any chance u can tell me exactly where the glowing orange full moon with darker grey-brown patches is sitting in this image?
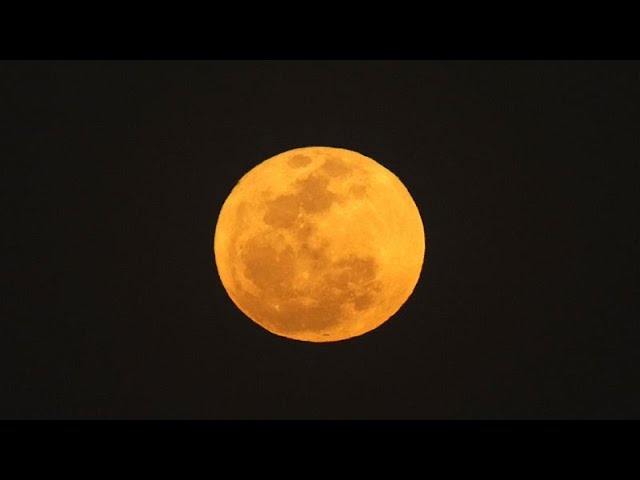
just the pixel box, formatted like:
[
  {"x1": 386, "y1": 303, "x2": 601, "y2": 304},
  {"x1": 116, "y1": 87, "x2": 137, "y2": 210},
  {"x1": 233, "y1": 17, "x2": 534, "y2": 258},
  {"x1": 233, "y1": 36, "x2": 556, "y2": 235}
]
[{"x1": 214, "y1": 147, "x2": 425, "y2": 342}]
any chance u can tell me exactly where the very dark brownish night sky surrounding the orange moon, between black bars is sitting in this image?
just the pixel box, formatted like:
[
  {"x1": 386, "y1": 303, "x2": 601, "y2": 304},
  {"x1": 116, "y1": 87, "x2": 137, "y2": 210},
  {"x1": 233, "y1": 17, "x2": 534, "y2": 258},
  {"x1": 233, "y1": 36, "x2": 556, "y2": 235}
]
[{"x1": 0, "y1": 60, "x2": 640, "y2": 419}]
